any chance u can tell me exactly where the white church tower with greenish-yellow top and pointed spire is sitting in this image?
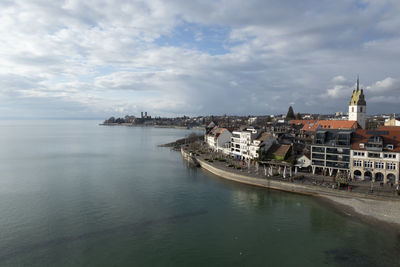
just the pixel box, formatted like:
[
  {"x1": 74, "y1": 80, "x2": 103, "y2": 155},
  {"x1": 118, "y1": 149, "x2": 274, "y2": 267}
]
[{"x1": 349, "y1": 77, "x2": 367, "y2": 129}]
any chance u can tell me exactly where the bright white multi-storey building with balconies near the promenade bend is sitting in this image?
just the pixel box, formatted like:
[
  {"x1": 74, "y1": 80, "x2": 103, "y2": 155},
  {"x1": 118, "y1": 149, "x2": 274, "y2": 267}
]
[{"x1": 231, "y1": 128, "x2": 259, "y2": 159}]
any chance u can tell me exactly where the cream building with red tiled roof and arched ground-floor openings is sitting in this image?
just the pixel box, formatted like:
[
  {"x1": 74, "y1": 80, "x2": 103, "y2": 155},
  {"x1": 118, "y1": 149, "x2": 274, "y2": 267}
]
[{"x1": 350, "y1": 127, "x2": 400, "y2": 184}]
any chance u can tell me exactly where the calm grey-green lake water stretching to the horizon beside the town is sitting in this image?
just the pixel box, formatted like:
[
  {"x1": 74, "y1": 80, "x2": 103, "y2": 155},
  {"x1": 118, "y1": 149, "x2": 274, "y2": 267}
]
[{"x1": 0, "y1": 121, "x2": 400, "y2": 266}]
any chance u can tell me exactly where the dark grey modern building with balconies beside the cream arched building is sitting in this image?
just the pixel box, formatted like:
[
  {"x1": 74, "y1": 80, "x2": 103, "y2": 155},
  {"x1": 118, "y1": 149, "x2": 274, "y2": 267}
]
[{"x1": 311, "y1": 130, "x2": 353, "y2": 176}]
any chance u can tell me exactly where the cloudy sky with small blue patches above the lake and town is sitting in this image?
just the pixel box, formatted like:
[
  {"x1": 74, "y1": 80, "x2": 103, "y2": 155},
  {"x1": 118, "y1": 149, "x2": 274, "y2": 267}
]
[{"x1": 0, "y1": 0, "x2": 400, "y2": 119}]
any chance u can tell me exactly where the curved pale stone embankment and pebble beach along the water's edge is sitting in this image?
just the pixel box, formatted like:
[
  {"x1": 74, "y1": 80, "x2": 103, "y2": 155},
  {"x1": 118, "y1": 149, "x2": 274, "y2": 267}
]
[{"x1": 181, "y1": 149, "x2": 400, "y2": 232}]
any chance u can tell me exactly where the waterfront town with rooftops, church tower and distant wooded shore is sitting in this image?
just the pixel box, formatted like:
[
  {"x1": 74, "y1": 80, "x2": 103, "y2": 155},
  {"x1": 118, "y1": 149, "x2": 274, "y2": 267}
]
[{"x1": 104, "y1": 79, "x2": 400, "y2": 196}]
